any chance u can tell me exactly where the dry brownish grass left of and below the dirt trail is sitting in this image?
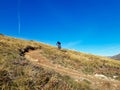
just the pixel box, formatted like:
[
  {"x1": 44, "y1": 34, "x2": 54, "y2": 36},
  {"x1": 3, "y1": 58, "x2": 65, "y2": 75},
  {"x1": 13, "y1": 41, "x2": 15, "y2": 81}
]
[{"x1": 0, "y1": 35, "x2": 94, "y2": 90}]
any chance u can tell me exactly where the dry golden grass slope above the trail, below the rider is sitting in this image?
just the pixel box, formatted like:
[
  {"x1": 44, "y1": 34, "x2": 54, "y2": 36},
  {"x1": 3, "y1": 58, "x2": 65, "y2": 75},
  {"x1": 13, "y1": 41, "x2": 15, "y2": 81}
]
[{"x1": 40, "y1": 43, "x2": 120, "y2": 76}]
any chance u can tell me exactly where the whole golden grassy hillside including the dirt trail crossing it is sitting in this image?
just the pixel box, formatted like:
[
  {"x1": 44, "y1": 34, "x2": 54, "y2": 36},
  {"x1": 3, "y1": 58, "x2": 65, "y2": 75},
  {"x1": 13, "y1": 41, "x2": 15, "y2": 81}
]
[{"x1": 0, "y1": 35, "x2": 120, "y2": 90}]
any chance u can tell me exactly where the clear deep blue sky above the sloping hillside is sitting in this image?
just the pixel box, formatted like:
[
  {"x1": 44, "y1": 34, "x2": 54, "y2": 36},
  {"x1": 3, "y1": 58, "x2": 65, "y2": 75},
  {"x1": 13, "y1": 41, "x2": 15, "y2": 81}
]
[{"x1": 0, "y1": 0, "x2": 120, "y2": 56}]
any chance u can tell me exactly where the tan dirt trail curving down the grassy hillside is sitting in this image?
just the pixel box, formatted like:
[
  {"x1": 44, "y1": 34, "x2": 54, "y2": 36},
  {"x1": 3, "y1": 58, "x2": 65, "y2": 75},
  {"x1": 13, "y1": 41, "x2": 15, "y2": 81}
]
[{"x1": 25, "y1": 50, "x2": 120, "y2": 86}]
